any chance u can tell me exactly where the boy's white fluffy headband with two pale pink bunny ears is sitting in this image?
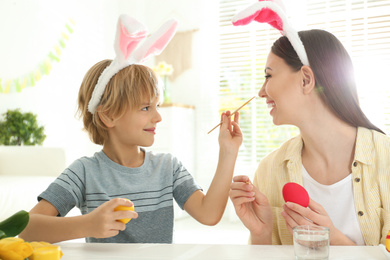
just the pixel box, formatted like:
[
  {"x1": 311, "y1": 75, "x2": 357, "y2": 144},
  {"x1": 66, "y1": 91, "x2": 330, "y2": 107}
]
[{"x1": 88, "y1": 14, "x2": 177, "y2": 114}]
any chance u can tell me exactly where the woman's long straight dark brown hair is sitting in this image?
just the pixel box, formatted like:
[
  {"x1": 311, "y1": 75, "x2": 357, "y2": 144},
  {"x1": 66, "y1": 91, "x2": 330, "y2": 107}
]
[{"x1": 271, "y1": 30, "x2": 385, "y2": 134}]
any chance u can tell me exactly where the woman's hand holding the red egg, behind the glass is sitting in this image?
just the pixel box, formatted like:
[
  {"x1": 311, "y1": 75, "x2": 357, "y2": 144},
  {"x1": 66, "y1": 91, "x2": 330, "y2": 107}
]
[{"x1": 282, "y1": 199, "x2": 355, "y2": 245}]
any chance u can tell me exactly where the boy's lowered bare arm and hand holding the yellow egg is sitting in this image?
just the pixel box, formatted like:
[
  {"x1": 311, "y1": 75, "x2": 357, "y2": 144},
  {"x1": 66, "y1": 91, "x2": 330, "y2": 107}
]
[{"x1": 19, "y1": 198, "x2": 138, "y2": 243}]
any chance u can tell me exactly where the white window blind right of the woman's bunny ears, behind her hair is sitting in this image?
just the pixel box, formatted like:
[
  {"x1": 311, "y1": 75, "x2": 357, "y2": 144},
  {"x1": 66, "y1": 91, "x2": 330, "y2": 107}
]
[{"x1": 306, "y1": 0, "x2": 390, "y2": 134}]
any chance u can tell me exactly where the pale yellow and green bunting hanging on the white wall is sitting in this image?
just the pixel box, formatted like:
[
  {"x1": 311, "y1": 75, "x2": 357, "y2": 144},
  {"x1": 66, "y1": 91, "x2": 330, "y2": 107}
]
[{"x1": 0, "y1": 19, "x2": 75, "y2": 94}]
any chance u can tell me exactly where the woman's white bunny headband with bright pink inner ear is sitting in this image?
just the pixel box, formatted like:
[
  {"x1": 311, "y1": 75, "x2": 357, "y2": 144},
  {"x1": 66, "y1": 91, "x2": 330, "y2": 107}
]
[{"x1": 232, "y1": 0, "x2": 309, "y2": 66}]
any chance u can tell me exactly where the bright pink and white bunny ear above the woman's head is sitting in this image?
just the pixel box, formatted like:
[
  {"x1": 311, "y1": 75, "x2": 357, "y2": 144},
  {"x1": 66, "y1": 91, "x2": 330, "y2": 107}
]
[{"x1": 232, "y1": 1, "x2": 283, "y2": 32}]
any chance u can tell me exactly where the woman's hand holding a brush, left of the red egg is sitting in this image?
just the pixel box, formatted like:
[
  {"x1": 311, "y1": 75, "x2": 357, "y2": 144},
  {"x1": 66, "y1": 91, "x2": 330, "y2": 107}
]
[{"x1": 229, "y1": 176, "x2": 273, "y2": 244}]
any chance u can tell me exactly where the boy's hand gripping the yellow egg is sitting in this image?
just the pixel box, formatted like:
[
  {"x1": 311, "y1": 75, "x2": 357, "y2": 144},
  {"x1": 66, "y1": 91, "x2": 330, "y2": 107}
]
[{"x1": 86, "y1": 198, "x2": 138, "y2": 238}]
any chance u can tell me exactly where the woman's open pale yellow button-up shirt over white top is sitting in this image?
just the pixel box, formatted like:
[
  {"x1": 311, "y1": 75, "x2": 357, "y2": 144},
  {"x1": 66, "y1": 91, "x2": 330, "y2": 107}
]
[{"x1": 253, "y1": 127, "x2": 390, "y2": 245}]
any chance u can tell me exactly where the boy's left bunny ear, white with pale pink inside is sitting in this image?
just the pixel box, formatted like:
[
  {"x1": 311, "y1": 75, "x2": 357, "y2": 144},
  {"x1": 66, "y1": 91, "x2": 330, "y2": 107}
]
[{"x1": 114, "y1": 14, "x2": 148, "y2": 60}]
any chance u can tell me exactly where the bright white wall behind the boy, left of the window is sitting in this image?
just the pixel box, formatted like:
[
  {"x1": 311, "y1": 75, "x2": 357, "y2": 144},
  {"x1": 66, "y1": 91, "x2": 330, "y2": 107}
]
[{"x1": 0, "y1": 0, "x2": 219, "y2": 189}]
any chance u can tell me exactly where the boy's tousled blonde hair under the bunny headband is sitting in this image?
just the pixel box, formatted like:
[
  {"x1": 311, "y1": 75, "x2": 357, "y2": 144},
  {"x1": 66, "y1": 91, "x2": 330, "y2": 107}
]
[{"x1": 78, "y1": 60, "x2": 162, "y2": 145}]
